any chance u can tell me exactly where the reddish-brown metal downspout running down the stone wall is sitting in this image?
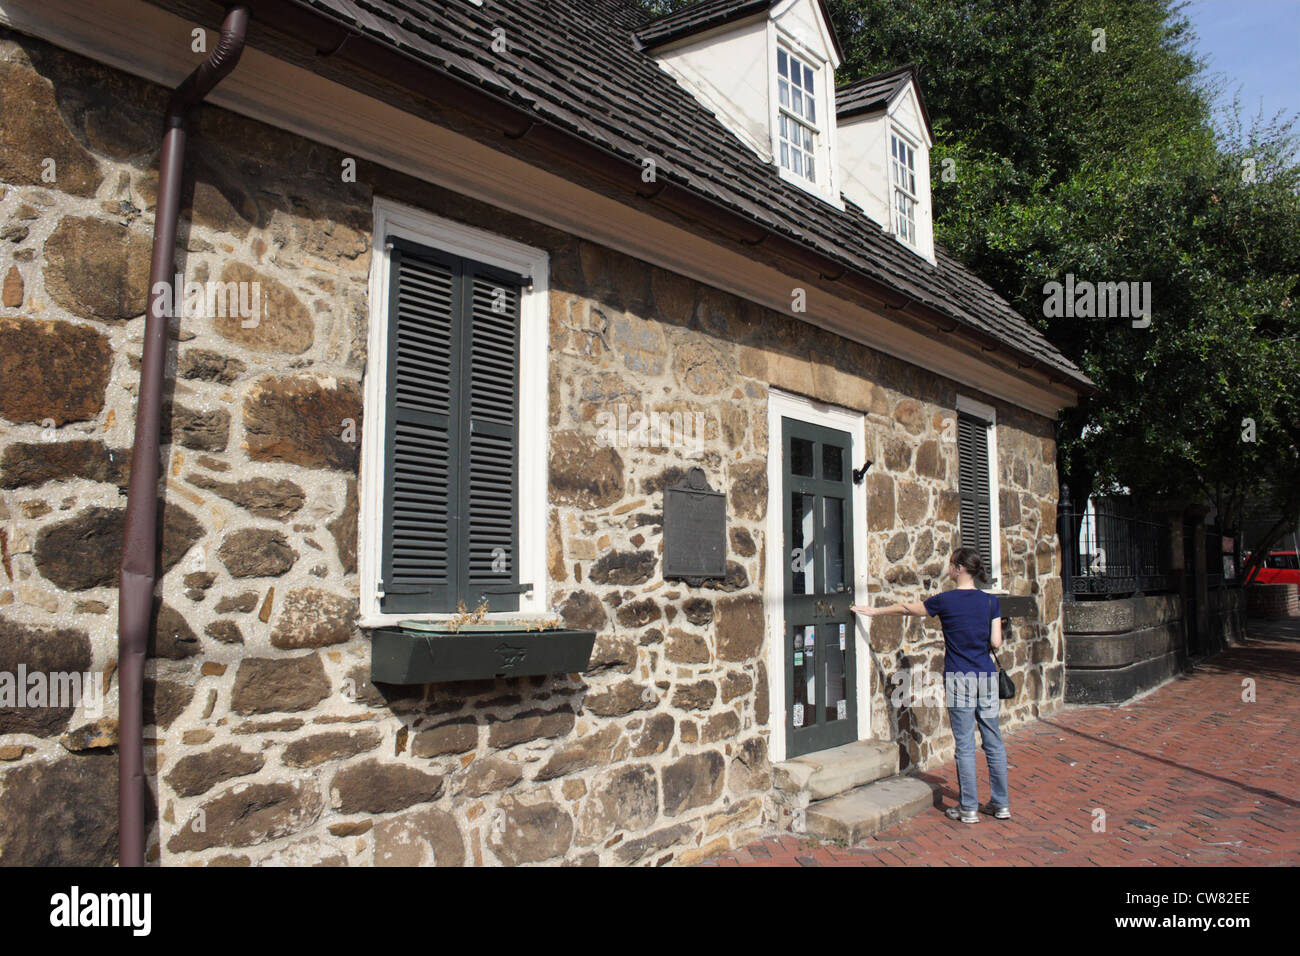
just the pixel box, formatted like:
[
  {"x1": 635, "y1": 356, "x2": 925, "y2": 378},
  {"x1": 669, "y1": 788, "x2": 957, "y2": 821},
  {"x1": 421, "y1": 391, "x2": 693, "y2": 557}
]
[{"x1": 117, "y1": 5, "x2": 248, "y2": 866}]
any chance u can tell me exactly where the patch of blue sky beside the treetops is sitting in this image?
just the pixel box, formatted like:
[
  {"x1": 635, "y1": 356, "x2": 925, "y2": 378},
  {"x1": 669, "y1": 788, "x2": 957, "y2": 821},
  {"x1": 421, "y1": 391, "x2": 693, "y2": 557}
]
[{"x1": 1183, "y1": 0, "x2": 1300, "y2": 126}]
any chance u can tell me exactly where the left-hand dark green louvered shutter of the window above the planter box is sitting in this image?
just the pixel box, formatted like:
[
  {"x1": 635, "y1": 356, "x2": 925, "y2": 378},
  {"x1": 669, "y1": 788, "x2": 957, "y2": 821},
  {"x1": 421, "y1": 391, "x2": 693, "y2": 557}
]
[{"x1": 380, "y1": 241, "x2": 462, "y2": 613}]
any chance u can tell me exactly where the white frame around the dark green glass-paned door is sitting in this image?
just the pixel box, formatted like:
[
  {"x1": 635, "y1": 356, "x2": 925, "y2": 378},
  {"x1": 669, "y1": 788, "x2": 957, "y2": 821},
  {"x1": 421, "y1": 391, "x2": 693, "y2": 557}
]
[{"x1": 763, "y1": 388, "x2": 871, "y2": 762}]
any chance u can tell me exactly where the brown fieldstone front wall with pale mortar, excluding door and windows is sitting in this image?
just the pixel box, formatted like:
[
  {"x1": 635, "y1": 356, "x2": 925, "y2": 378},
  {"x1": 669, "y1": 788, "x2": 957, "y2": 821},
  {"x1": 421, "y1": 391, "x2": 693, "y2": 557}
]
[{"x1": 0, "y1": 33, "x2": 1065, "y2": 865}]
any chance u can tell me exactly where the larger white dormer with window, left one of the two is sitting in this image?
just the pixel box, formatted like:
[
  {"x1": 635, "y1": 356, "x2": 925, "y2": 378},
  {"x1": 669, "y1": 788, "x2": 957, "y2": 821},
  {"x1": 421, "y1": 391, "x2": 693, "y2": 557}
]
[{"x1": 654, "y1": 0, "x2": 844, "y2": 209}]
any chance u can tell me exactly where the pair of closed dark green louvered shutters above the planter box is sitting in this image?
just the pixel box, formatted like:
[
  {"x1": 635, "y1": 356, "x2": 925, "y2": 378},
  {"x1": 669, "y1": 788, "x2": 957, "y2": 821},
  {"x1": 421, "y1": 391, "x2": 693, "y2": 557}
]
[{"x1": 380, "y1": 239, "x2": 529, "y2": 613}]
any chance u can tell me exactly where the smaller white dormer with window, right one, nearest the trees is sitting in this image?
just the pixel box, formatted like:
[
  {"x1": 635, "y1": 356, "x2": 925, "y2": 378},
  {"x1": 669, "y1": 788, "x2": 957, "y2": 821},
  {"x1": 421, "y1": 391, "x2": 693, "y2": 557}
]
[{"x1": 837, "y1": 73, "x2": 935, "y2": 264}]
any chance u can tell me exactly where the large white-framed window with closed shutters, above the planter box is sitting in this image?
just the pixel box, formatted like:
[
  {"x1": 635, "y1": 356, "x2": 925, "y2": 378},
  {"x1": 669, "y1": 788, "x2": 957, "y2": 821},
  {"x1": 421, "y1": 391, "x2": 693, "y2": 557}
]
[{"x1": 358, "y1": 199, "x2": 549, "y2": 627}]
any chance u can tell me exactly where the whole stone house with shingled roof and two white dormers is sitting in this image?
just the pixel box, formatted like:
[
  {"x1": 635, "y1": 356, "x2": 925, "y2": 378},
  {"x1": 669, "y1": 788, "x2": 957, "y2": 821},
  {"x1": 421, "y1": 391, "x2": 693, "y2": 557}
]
[{"x1": 0, "y1": 0, "x2": 1092, "y2": 865}]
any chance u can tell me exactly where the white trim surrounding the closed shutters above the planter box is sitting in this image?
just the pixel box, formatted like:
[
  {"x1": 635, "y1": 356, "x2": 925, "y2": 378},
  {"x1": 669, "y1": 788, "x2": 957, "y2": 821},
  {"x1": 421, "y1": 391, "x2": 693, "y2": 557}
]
[{"x1": 356, "y1": 198, "x2": 550, "y2": 627}]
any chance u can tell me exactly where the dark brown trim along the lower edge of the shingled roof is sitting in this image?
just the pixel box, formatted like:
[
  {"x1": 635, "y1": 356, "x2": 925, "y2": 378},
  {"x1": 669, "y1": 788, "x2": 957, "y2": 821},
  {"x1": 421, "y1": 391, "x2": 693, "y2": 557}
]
[{"x1": 200, "y1": 0, "x2": 1097, "y2": 395}]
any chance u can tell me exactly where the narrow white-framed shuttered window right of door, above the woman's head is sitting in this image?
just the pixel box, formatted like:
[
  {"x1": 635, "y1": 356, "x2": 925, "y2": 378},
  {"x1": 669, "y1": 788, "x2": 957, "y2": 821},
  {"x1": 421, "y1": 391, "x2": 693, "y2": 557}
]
[{"x1": 957, "y1": 395, "x2": 1002, "y2": 591}]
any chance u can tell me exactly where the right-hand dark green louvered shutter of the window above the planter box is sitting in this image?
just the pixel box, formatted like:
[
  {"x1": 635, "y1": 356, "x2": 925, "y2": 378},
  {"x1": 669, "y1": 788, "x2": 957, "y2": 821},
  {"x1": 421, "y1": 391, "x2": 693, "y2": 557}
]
[{"x1": 460, "y1": 263, "x2": 527, "y2": 611}]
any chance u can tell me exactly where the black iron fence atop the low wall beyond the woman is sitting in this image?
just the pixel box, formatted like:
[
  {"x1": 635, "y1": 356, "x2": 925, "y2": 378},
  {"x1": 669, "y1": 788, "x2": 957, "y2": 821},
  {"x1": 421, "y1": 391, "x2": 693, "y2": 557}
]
[{"x1": 1058, "y1": 494, "x2": 1180, "y2": 597}]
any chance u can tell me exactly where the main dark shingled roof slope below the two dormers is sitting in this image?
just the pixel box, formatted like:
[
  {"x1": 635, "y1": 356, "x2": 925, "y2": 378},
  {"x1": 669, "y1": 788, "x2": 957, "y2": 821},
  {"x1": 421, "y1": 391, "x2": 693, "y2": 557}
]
[{"x1": 269, "y1": 0, "x2": 1092, "y2": 392}]
